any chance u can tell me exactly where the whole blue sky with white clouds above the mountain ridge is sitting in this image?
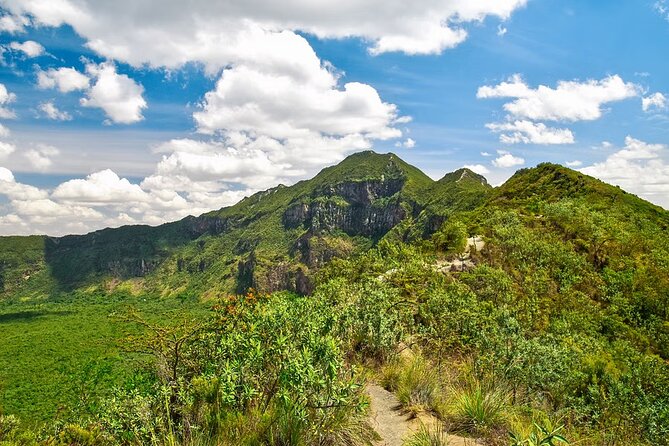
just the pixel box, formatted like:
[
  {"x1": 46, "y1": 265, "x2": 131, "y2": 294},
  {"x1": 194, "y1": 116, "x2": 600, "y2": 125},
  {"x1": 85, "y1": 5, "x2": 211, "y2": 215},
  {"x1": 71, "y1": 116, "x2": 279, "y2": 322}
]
[{"x1": 0, "y1": 0, "x2": 669, "y2": 235}]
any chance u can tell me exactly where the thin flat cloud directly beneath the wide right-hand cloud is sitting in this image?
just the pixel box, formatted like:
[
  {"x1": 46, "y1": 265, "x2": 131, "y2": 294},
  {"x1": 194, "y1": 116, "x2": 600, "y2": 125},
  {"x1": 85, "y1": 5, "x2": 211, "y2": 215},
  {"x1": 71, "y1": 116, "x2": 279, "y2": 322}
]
[{"x1": 486, "y1": 120, "x2": 574, "y2": 144}]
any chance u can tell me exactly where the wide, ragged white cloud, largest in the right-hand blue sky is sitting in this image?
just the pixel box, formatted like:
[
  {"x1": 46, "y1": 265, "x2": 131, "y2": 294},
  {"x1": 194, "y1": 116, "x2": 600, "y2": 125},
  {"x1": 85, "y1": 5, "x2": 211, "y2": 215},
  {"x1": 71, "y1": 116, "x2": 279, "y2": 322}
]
[{"x1": 476, "y1": 75, "x2": 641, "y2": 121}]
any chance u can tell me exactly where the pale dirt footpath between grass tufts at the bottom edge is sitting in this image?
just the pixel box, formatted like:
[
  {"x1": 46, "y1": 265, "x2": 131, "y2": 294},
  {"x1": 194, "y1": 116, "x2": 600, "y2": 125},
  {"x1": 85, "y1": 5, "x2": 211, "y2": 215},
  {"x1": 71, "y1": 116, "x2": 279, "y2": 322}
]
[{"x1": 367, "y1": 383, "x2": 477, "y2": 446}]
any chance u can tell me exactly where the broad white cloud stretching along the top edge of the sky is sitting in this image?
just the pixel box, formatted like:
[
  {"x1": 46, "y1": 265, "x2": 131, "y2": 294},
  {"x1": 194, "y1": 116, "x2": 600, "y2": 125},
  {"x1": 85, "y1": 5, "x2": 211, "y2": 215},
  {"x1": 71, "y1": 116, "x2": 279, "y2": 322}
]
[{"x1": 5, "y1": 0, "x2": 527, "y2": 68}]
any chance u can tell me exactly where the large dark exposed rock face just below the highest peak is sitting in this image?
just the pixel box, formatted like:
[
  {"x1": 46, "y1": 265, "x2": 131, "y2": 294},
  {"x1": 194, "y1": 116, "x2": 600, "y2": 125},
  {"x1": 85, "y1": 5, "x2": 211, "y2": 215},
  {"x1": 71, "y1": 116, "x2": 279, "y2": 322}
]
[{"x1": 283, "y1": 179, "x2": 407, "y2": 237}]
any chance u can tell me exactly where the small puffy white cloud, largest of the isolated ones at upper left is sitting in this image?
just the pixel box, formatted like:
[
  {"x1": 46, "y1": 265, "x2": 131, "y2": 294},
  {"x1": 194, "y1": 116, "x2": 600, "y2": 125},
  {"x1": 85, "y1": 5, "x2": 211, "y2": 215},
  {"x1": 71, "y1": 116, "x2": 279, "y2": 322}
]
[{"x1": 81, "y1": 62, "x2": 147, "y2": 124}]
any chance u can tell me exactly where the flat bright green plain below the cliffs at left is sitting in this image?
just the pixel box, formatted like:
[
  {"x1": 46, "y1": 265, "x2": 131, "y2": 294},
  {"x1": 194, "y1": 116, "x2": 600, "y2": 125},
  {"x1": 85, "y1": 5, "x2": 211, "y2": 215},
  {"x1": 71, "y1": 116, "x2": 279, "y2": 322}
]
[{"x1": 0, "y1": 291, "x2": 207, "y2": 422}]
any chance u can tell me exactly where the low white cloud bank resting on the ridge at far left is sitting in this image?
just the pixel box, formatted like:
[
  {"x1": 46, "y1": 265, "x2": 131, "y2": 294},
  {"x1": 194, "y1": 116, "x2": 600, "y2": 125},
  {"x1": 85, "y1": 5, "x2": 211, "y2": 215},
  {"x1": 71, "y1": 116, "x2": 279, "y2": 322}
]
[{"x1": 0, "y1": 161, "x2": 254, "y2": 235}]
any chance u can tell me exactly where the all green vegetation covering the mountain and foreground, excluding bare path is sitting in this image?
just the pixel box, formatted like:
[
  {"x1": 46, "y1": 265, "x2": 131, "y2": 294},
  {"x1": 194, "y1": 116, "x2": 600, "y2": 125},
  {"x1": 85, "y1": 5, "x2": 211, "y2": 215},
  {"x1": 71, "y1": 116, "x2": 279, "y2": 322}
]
[{"x1": 0, "y1": 152, "x2": 669, "y2": 446}]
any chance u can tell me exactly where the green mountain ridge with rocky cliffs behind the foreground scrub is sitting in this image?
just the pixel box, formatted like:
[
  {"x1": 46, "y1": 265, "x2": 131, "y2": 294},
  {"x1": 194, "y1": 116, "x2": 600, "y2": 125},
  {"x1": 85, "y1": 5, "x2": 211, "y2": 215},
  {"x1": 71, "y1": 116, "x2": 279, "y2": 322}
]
[{"x1": 0, "y1": 151, "x2": 669, "y2": 302}]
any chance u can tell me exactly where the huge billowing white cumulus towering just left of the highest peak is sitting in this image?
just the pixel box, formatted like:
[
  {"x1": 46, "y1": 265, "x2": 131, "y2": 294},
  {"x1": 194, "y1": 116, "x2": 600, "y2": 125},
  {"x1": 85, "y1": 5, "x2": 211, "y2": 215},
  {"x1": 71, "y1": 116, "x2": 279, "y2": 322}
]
[{"x1": 185, "y1": 30, "x2": 408, "y2": 187}]
